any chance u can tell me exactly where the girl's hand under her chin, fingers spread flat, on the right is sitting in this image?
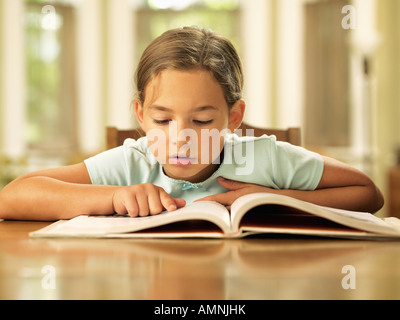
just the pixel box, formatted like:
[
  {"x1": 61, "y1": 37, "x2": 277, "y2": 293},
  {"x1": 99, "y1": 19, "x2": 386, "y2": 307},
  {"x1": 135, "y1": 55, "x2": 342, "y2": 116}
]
[{"x1": 195, "y1": 177, "x2": 276, "y2": 209}]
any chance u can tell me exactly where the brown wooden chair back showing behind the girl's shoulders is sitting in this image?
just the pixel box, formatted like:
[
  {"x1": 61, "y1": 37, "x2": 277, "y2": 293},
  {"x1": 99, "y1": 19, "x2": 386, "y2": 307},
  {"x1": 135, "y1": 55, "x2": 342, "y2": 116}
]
[{"x1": 106, "y1": 123, "x2": 301, "y2": 149}]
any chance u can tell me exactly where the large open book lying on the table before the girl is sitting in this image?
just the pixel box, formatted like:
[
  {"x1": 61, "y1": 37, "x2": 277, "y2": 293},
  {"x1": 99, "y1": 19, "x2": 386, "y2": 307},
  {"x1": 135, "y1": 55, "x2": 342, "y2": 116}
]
[{"x1": 30, "y1": 193, "x2": 400, "y2": 239}]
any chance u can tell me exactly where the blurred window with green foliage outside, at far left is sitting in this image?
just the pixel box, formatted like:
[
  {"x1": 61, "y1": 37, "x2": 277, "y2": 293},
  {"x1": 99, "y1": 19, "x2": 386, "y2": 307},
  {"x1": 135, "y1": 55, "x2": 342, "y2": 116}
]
[{"x1": 25, "y1": 0, "x2": 77, "y2": 154}]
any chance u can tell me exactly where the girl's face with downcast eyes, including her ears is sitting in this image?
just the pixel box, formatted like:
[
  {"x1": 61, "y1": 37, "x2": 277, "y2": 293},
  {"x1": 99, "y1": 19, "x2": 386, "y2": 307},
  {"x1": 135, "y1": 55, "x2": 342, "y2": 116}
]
[{"x1": 135, "y1": 69, "x2": 245, "y2": 182}]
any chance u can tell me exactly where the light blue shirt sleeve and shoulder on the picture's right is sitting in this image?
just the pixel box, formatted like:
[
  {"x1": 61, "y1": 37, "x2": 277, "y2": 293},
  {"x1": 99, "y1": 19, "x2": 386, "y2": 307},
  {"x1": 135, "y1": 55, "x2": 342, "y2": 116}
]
[{"x1": 221, "y1": 135, "x2": 324, "y2": 190}]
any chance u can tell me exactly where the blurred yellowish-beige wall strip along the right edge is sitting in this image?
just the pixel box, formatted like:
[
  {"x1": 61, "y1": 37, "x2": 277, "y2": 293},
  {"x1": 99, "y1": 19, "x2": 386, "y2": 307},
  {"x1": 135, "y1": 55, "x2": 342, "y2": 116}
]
[{"x1": 374, "y1": 0, "x2": 400, "y2": 215}]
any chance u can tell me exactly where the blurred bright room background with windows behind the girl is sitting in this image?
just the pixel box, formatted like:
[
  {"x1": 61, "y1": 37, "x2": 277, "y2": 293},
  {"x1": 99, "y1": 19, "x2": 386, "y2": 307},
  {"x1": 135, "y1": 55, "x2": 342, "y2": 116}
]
[{"x1": 0, "y1": 0, "x2": 400, "y2": 215}]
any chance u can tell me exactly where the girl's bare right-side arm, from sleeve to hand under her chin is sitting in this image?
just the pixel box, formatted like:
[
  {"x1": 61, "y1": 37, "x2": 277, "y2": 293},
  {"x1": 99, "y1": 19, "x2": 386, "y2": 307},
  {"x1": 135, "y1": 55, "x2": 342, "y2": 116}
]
[{"x1": 199, "y1": 157, "x2": 384, "y2": 213}]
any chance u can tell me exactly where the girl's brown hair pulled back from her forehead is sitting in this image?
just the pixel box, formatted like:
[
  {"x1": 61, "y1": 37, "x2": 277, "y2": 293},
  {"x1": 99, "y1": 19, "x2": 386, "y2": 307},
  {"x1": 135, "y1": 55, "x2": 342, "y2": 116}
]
[{"x1": 135, "y1": 27, "x2": 243, "y2": 107}]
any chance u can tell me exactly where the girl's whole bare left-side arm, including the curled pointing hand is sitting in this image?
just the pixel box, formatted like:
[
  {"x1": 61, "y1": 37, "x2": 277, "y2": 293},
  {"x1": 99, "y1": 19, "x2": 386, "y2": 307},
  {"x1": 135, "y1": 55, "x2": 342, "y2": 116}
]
[{"x1": 0, "y1": 163, "x2": 185, "y2": 221}]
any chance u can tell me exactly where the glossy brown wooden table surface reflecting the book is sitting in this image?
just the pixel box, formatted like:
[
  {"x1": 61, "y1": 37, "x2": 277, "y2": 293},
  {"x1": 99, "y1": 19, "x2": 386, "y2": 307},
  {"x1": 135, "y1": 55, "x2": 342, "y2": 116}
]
[{"x1": 0, "y1": 221, "x2": 400, "y2": 300}]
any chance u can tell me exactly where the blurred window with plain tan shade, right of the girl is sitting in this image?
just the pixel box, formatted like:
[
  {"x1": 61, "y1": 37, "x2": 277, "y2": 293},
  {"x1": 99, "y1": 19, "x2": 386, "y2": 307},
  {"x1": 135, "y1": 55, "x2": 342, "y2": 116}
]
[{"x1": 304, "y1": 1, "x2": 351, "y2": 147}]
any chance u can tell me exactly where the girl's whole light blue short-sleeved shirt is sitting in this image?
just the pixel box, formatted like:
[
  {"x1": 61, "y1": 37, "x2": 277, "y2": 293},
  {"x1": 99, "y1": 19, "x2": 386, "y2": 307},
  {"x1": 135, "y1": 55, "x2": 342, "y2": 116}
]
[{"x1": 85, "y1": 134, "x2": 324, "y2": 204}]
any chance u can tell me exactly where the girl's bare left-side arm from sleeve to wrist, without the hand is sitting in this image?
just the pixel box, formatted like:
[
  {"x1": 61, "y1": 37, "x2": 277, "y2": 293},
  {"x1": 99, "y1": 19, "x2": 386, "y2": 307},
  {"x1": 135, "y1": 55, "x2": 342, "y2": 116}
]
[{"x1": 0, "y1": 163, "x2": 114, "y2": 220}]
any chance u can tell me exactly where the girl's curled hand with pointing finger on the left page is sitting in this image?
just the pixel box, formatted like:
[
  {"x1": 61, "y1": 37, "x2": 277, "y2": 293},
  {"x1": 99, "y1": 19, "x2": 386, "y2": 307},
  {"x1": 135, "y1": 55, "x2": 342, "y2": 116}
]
[{"x1": 112, "y1": 183, "x2": 186, "y2": 217}]
